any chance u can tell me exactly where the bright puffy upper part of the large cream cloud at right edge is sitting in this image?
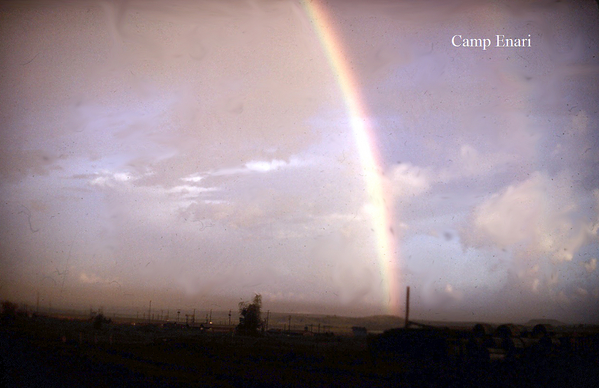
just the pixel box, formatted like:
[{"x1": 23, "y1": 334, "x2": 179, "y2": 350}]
[{"x1": 462, "y1": 173, "x2": 597, "y2": 262}]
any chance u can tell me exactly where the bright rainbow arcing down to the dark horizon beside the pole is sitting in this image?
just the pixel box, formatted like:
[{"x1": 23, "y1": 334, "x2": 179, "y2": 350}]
[{"x1": 302, "y1": 0, "x2": 399, "y2": 314}]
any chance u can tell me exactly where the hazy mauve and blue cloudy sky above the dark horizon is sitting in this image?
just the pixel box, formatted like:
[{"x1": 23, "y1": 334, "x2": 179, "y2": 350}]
[{"x1": 0, "y1": 0, "x2": 599, "y2": 323}]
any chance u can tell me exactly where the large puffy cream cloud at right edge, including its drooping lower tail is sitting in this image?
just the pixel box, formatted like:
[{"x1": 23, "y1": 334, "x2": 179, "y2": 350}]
[{"x1": 460, "y1": 172, "x2": 599, "y2": 303}]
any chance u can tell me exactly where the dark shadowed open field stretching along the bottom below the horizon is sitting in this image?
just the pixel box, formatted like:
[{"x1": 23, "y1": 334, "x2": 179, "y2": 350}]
[{"x1": 1, "y1": 316, "x2": 599, "y2": 387}]
